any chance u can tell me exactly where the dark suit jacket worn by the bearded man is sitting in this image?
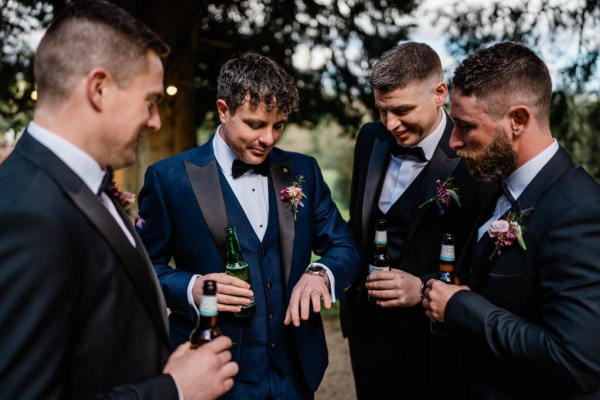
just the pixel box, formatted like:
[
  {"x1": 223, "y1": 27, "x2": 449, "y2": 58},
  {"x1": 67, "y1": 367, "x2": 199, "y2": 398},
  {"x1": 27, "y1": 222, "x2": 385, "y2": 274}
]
[{"x1": 445, "y1": 148, "x2": 600, "y2": 400}]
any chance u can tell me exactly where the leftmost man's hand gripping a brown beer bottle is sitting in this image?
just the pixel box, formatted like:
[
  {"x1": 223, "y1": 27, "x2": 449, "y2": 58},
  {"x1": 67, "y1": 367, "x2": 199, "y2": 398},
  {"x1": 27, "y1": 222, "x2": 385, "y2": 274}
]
[{"x1": 163, "y1": 336, "x2": 239, "y2": 400}]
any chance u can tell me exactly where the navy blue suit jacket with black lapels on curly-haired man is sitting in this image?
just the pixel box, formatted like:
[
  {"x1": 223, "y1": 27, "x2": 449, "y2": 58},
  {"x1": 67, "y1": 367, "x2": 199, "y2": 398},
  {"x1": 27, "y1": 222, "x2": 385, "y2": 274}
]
[{"x1": 139, "y1": 138, "x2": 360, "y2": 390}]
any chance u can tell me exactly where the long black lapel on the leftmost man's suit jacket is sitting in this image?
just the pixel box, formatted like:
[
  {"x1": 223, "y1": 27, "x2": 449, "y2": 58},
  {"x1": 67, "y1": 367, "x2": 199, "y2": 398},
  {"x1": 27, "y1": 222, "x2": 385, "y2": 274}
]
[{"x1": 20, "y1": 134, "x2": 169, "y2": 345}]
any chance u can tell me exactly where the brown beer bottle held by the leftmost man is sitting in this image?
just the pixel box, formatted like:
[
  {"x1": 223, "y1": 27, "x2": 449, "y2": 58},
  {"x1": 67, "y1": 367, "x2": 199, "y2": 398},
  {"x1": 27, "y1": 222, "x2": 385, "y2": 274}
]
[{"x1": 190, "y1": 279, "x2": 221, "y2": 349}]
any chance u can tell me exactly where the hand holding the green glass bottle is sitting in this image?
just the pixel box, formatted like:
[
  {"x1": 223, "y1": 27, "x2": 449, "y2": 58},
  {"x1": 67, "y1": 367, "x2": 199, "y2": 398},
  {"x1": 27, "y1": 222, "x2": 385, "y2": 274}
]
[{"x1": 192, "y1": 272, "x2": 254, "y2": 312}]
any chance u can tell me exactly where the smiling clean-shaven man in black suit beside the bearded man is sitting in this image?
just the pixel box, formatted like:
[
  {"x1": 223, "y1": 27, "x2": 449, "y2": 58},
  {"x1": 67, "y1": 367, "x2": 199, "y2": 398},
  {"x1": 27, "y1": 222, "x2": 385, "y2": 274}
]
[{"x1": 341, "y1": 42, "x2": 486, "y2": 399}]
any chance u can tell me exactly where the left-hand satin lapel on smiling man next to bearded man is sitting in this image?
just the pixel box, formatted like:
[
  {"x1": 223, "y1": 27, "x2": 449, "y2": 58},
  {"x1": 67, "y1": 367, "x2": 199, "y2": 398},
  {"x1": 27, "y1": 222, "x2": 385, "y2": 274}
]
[{"x1": 361, "y1": 138, "x2": 390, "y2": 248}]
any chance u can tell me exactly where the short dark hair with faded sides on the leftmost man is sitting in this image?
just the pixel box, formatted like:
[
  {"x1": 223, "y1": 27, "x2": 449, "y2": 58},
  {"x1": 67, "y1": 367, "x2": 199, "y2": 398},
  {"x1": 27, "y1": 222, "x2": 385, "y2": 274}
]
[{"x1": 34, "y1": 0, "x2": 169, "y2": 104}]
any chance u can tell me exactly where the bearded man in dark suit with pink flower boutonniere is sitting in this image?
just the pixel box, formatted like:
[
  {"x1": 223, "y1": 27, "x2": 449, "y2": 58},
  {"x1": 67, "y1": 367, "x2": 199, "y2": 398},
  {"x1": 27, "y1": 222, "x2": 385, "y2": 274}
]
[{"x1": 423, "y1": 42, "x2": 600, "y2": 400}]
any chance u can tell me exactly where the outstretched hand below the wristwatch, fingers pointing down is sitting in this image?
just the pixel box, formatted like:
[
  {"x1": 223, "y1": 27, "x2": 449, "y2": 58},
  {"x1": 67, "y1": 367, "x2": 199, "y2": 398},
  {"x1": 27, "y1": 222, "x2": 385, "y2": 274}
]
[{"x1": 283, "y1": 274, "x2": 331, "y2": 327}]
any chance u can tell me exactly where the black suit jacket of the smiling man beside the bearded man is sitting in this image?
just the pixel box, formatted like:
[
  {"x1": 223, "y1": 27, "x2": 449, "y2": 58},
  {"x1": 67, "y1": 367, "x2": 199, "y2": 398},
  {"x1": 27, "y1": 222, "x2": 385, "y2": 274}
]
[{"x1": 341, "y1": 117, "x2": 480, "y2": 343}]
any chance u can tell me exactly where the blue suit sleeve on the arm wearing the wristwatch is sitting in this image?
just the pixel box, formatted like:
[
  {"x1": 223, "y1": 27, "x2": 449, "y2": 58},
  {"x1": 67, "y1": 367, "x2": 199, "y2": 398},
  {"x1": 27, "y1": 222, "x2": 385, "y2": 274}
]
[{"x1": 313, "y1": 159, "x2": 361, "y2": 298}]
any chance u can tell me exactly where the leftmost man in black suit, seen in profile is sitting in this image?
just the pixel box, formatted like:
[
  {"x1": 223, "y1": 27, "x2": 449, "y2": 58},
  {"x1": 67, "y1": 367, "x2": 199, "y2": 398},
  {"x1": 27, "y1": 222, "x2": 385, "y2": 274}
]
[{"x1": 0, "y1": 1, "x2": 237, "y2": 400}]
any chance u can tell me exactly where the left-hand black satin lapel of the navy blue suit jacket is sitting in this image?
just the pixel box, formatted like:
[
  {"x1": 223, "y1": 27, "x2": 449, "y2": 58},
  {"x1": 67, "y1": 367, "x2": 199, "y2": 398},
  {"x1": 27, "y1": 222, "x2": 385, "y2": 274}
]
[{"x1": 185, "y1": 158, "x2": 227, "y2": 260}]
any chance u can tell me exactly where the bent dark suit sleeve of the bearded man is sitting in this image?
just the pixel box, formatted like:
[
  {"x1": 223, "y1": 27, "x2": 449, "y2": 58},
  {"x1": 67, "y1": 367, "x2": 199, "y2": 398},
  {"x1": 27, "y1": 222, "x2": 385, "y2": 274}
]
[{"x1": 445, "y1": 202, "x2": 600, "y2": 392}]
